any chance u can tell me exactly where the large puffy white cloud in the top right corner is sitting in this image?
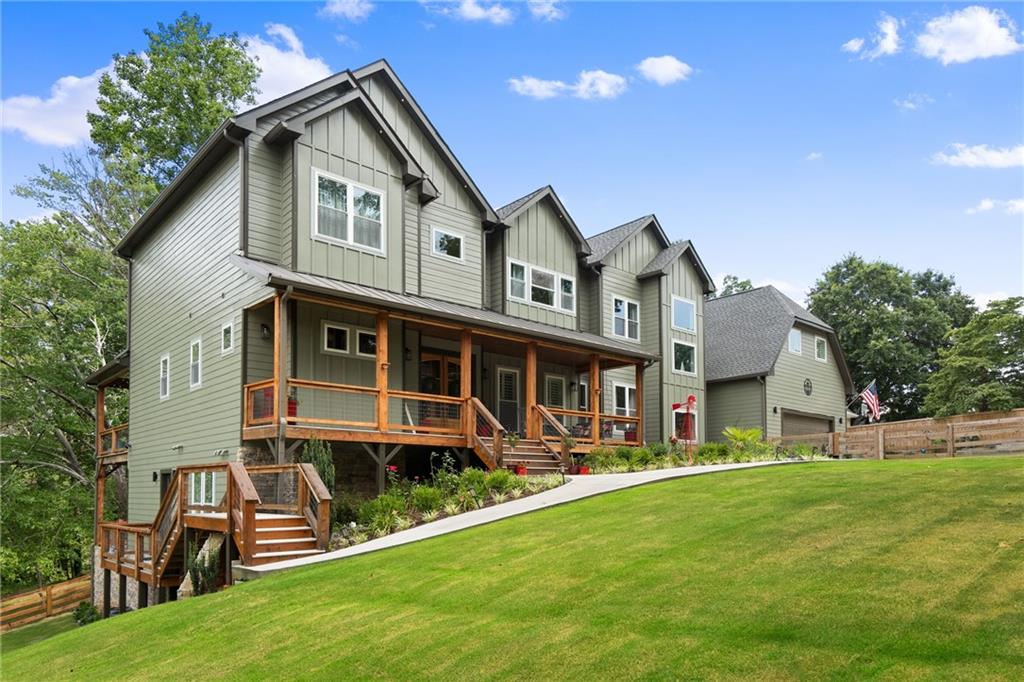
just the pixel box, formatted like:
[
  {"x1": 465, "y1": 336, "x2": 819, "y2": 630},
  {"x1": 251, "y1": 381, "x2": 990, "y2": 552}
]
[{"x1": 916, "y1": 5, "x2": 1024, "y2": 66}]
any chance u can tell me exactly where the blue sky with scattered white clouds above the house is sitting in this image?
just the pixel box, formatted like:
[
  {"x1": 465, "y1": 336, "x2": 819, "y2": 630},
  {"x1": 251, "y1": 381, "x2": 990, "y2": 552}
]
[{"x1": 0, "y1": 0, "x2": 1024, "y2": 300}]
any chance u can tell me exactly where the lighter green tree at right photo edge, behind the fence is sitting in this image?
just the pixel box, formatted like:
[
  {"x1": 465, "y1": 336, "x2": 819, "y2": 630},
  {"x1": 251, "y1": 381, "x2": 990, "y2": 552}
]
[{"x1": 925, "y1": 297, "x2": 1024, "y2": 417}]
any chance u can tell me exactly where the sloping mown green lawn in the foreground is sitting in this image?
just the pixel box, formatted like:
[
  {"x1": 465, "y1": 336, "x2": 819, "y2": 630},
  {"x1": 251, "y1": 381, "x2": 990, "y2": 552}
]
[{"x1": 2, "y1": 458, "x2": 1024, "y2": 680}]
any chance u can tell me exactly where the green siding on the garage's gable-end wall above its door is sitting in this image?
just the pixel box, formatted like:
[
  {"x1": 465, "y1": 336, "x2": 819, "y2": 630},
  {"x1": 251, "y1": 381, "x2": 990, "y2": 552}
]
[{"x1": 765, "y1": 325, "x2": 846, "y2": 437}]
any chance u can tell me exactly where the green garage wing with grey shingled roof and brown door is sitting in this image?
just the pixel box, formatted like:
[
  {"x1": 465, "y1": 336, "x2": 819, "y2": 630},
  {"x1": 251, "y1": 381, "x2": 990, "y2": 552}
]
[{"x1": 705, "y1": 287, "x2": 853, "y2": 440}]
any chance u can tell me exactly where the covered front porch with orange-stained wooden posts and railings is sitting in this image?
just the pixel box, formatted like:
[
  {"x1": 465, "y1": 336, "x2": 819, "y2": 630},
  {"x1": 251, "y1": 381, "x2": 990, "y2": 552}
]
[{"x1": 243, "y1": 288, "x2": 650, "y2": 468}]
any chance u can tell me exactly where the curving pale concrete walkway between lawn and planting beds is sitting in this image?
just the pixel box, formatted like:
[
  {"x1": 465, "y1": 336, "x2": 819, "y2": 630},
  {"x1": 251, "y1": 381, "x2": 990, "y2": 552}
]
[{"x1": 233, "y1": 461, "x2": 799, "y2": 580}]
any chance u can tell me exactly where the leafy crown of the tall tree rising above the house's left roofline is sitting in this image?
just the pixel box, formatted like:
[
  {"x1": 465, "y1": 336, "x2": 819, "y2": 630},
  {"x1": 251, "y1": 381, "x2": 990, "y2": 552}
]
[{"x1": 88, "y1": 12, "x2": 260, "y2": 185}]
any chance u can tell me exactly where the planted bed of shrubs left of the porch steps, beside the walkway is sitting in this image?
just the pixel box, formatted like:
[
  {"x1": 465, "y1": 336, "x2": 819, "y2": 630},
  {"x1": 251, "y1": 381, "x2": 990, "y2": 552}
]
[{"x1": 329, "y1": 453, "x2": 563, "y2": 550}]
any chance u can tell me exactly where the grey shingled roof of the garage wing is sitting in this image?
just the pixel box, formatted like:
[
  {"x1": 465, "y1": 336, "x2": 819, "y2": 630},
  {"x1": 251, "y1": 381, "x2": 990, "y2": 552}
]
[{"x1": 705, "y1": 286, "x2": 853, "y2": 392}]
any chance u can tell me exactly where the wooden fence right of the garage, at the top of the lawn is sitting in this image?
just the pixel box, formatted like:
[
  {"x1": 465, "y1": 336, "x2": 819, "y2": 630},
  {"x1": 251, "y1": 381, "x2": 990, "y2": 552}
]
[{"x1": 771, "y1": 410, "x2": 1024, "y2": 459}]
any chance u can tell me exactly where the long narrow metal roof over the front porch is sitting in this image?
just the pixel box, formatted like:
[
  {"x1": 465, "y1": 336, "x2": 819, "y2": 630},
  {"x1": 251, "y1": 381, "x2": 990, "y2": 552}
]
[{"x1": 230, "y1": 255, "x2": 657, "y2": 360}]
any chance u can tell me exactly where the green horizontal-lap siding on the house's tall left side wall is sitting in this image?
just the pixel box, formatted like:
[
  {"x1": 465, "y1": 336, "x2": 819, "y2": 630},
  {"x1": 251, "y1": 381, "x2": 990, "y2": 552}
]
[{"x1": 128, "y1": 154, "x2": 267, "y2": 522}]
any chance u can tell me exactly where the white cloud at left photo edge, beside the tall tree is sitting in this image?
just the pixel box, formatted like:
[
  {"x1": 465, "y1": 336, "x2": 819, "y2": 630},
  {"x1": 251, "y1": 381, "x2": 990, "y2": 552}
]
[{"x1": 0, "y1": 65, "x2": 112, "y2": 146}]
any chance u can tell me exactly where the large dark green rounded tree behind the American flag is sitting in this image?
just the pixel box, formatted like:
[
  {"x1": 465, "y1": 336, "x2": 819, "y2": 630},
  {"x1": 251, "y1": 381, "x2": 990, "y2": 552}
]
[{"x1": 809, "y1": 254, "x2": 976, "y2": 420}]
